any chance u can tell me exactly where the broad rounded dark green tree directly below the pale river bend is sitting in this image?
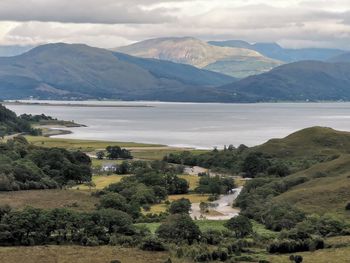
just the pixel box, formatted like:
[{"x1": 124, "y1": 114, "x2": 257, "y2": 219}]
[{"x1": 156, "y1": 214, "x2": 201, "y2": 245}]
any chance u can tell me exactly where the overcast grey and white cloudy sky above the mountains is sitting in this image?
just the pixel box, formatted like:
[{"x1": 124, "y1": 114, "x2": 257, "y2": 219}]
[{"x1": 0, "y1": 0, "x2": 350, "y2": 50}]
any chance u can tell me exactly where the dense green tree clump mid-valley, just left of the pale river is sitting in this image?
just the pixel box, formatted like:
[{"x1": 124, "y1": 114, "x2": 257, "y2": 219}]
[{"x1": 98, "y1": 161, "x2": 189, "y2": 218}]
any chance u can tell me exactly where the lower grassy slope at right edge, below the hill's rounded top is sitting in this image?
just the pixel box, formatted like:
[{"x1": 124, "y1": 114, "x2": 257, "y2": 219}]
[{"x1": 275, "y1": 154, "x2": 350, "y2": 219}]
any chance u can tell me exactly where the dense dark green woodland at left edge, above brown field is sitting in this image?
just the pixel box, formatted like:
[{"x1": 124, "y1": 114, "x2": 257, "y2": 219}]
[{"x1": 0, "y1": 136, "x2": 91, "y2": 191}]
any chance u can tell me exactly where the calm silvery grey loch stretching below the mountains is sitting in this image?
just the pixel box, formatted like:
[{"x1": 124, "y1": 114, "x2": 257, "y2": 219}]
[{"x1": 8, "y1": 102, "x2": 350, "y2": 148}]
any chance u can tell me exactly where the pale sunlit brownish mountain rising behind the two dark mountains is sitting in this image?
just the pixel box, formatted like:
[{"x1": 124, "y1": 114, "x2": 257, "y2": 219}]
[{"x1": 114, "y1": 37, "x2": 282, "y2": 78}]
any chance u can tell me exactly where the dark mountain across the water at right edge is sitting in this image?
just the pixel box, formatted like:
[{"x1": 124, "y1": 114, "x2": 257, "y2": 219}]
[{"x1": 219, "y1": 61, "x2": 350, "y2": 102}]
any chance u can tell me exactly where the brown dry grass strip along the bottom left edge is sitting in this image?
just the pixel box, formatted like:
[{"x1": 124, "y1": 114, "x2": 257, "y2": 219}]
[{"x1": 0, "y1": 246, "x2": 169, "y2": 263}]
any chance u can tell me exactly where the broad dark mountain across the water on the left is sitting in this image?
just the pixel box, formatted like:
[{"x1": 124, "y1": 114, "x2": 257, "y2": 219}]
[{"x1": 0, "y1": 43, "x2": 235, "y2": 101}]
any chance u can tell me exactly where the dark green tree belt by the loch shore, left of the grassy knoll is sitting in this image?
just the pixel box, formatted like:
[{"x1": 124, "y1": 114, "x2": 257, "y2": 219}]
[{"x1": 164, "y1": 150, "x2": 290, "y2": 178}]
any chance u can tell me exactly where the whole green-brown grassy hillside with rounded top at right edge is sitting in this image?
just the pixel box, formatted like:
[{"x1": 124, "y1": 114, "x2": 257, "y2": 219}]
[{"x1": 253, "y1": 127, "x2": 350, "y2": 218}]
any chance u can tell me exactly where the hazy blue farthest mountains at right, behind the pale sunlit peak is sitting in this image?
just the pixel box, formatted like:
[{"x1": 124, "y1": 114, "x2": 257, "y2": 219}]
[{"x1": 208, "y1": 40, "x2": 345, "y2": 62}]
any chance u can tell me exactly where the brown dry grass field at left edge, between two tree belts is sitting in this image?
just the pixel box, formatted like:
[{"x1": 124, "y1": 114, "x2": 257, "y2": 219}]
[{"x1": 0, "y1": 190, "x2": 98, "y2": 212}]
